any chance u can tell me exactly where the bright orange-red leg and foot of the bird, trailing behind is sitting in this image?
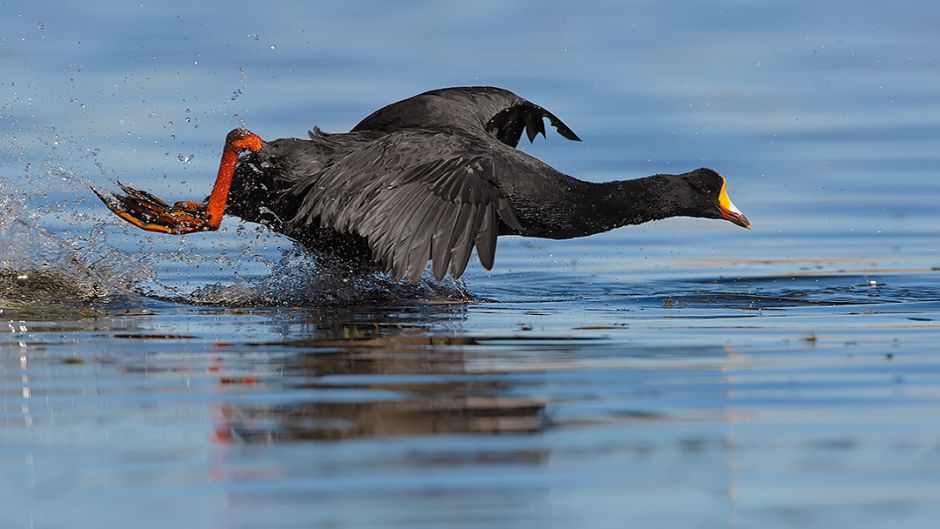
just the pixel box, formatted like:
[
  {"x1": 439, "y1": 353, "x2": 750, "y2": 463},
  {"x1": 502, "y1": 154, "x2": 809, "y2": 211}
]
[{"x1": 92, "y1": 129, "x2": 264, "y2": 235}]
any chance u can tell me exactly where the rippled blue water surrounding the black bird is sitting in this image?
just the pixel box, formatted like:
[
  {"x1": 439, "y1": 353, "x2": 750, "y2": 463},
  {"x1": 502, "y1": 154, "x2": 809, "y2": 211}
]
[{"x1": 0, "y1": 1, "x2": 940, "y2": 528}]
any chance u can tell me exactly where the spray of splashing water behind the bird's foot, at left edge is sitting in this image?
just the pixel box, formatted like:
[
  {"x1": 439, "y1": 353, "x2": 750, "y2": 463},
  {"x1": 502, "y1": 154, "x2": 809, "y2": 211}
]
[{"x1": 0, "y1": 127, "x2": 152, "y2": 318}]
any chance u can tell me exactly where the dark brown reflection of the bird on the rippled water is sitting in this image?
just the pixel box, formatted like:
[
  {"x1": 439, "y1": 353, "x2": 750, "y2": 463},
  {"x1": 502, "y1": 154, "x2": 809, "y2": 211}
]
[{"x1": 218, "y1": 312, "x2": 547, "y2": 443}]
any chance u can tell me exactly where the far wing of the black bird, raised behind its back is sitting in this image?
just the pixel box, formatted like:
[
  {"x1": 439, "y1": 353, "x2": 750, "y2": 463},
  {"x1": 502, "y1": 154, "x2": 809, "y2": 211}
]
[{"x1": 352, "y1": 86, "x2": 581, "y2": 147}]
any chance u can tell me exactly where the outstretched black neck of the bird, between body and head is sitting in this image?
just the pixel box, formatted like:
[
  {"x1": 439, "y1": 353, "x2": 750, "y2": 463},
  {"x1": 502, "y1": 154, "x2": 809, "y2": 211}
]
[{"x1": 552, "y1": 175, "x2": 689, "y2": 238}]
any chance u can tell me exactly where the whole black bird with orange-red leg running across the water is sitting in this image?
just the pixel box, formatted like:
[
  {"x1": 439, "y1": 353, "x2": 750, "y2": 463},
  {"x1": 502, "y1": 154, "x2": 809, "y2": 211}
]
[{"x1": 95, "y1": 87, "x2": 750, "y2": 280}]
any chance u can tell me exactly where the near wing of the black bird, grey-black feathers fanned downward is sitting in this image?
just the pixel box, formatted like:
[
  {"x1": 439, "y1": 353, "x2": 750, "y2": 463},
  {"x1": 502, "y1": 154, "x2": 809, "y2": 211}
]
[{"x1": 290, "y1": 129, "x2": 520, "y2": 281}]
